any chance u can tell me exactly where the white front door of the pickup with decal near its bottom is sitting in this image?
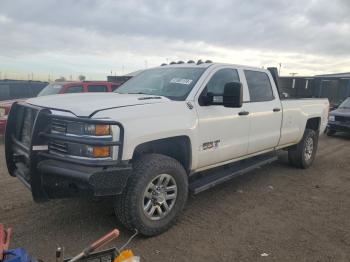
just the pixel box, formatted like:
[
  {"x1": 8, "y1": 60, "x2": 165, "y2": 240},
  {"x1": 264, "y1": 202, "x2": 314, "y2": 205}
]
[{"x1": 197, "y1": 67, "x2": 250, "y2": 168}]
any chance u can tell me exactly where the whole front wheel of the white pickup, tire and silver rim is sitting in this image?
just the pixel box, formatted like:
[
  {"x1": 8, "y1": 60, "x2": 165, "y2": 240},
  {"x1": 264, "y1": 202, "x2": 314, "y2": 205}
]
[{"x1": 115, "y1": 154, "x2": 188, "y2": 236}]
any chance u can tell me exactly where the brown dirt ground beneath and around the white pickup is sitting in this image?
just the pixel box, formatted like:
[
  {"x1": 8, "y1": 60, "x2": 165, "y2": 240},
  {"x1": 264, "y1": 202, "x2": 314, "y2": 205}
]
[{"x1": 0, "y1": 134, "x2": 350, "y2": 262}]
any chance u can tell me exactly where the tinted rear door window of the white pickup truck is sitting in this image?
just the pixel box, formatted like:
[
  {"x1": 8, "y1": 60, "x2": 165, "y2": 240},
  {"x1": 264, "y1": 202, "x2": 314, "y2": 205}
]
[{"x1": 244, "y1": 70, "x2": 274, "y2": 102}]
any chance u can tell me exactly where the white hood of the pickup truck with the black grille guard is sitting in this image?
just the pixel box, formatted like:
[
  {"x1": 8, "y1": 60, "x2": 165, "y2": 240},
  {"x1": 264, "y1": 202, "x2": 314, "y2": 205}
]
[{"x1": 27, "y1": 93, "x2": 170, "y2": 116}]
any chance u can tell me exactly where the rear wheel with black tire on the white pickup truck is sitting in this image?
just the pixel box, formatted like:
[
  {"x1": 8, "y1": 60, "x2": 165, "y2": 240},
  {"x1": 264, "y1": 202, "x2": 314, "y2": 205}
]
[{"x1": 288, "y1": 129, "x2": 318, "y2": 169}]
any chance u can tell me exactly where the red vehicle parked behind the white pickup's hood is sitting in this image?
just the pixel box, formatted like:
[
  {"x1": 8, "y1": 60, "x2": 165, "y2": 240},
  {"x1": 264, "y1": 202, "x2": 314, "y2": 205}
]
[{"x1": 0, "y1": 81, "x2": 121, "y2": 135}]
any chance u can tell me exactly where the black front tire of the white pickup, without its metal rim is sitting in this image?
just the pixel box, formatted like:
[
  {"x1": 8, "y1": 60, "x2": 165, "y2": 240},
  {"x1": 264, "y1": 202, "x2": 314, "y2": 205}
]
[{"x1": 114, "y1": 154, "x2": 188, "y2": 236}]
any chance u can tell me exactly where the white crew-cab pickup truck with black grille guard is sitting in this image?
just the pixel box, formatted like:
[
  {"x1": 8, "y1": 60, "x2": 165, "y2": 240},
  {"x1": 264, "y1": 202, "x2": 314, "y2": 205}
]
[{"x1": 5, "y1": 62, "x2": 329, "y2": 236}]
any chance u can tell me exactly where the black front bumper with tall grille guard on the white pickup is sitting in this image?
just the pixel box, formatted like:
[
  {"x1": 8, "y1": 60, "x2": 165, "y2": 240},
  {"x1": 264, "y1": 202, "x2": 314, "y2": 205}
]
[{"x1": 5, "y1": 101, "x2": 132, "y2": 202}]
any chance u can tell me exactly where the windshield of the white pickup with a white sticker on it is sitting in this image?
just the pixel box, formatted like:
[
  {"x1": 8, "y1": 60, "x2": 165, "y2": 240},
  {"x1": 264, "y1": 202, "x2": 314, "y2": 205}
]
[{"x1": 115, "y1": 67, "x2": 205, "y2": 100}]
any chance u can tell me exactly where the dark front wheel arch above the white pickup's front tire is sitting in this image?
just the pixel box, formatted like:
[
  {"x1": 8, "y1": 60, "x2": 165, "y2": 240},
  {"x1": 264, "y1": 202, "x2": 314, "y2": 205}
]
[{"x1": 132, "y1": 135, "x2": 192, "y2": 173}]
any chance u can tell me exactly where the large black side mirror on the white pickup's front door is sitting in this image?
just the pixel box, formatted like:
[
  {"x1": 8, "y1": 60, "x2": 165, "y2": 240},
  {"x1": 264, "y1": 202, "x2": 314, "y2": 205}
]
[{"x1": 222, "y1": 82, "x2": 243, "y2": 108}]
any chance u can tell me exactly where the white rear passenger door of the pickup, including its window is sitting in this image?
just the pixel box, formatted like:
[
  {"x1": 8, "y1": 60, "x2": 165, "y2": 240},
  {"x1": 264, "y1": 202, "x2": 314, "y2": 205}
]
[{"x1": 243, "y1": 70, "x2": 282, "y2": 154}]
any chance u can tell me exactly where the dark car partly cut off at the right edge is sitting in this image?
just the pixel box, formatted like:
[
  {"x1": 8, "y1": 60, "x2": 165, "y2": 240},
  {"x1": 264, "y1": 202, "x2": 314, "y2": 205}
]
[{"x1": 327, "y1": 97, "x2": 350, "y2": 136}]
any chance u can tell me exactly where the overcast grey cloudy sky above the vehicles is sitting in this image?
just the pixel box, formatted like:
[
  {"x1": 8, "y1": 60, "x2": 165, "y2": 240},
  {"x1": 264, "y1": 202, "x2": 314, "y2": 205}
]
[{"x1": 0, "y1": 0, "x2": 350, "y2": 80}]
